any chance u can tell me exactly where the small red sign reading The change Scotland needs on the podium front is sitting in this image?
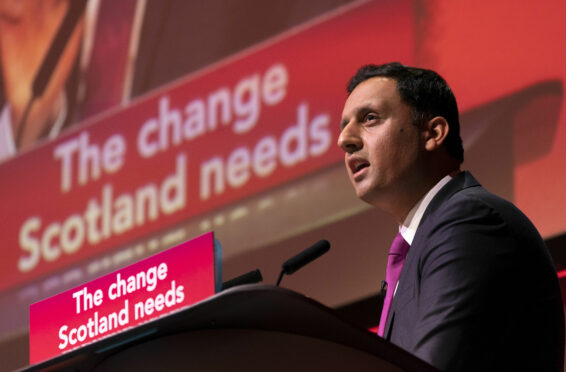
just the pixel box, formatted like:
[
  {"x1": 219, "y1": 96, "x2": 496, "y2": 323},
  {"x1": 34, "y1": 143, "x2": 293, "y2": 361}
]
[{"x1": 29, "y1": 232, "x2": 220, "y2": 364}]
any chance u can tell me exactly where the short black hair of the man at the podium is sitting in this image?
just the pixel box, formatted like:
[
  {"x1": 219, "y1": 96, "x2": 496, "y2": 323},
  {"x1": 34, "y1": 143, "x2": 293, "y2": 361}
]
[{"x1": 347, "y1": 62, "x2": 464, "y2": 163}]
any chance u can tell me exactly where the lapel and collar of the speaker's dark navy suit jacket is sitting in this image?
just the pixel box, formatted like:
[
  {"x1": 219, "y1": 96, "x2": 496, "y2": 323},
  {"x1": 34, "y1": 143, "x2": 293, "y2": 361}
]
[{"x1": 383, "y1": 171, "x2": 480, "y2": 340}]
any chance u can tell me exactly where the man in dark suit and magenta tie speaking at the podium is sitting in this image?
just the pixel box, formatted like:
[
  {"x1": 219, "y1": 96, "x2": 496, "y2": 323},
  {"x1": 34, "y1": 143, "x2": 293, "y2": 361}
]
[{"x1": 338, "y1": 63, "x2": 564, "y2": 371}]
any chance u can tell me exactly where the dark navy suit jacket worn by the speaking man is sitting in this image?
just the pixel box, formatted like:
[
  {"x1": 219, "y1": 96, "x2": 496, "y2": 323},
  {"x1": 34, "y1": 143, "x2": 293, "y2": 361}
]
[{"x1": 384, "y1": 172, "x2": 564, "y2": 371}]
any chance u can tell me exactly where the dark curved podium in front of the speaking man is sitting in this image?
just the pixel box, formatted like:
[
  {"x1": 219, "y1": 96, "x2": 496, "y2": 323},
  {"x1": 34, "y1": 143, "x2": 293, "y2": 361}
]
[{"x1": 24, "y1": 284, "x2": 437, "y2": 372}]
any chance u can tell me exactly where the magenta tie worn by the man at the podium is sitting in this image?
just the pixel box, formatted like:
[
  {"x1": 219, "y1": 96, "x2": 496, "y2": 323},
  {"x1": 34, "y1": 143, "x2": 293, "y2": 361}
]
[{"x1": 377, "y1": 233, "x2": 410, "y2": 337}]
